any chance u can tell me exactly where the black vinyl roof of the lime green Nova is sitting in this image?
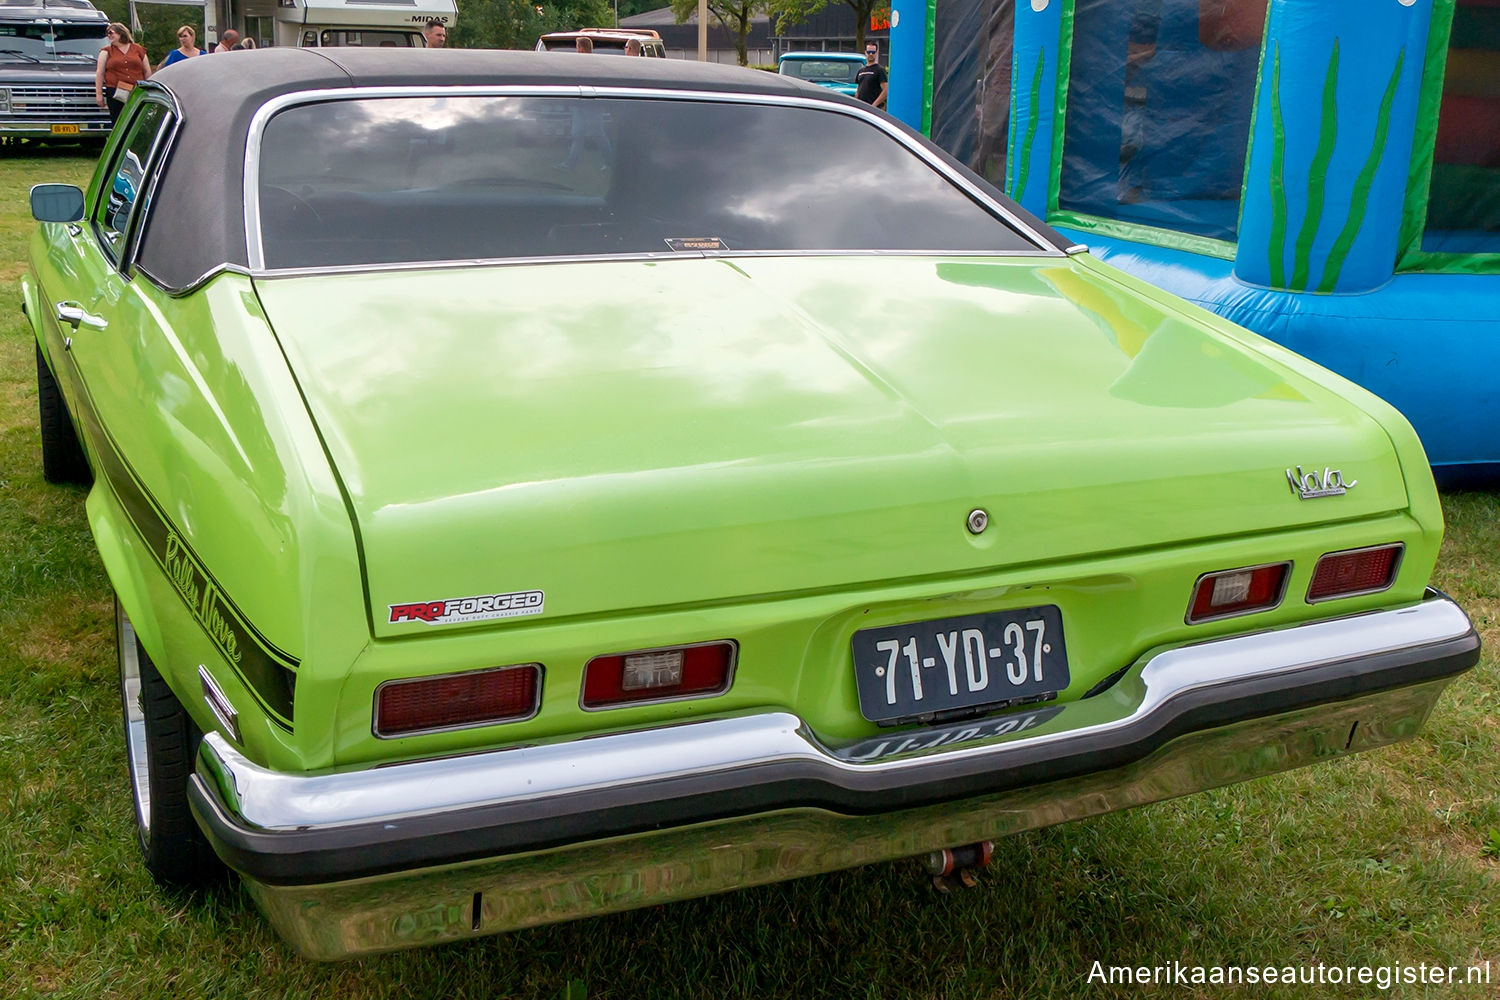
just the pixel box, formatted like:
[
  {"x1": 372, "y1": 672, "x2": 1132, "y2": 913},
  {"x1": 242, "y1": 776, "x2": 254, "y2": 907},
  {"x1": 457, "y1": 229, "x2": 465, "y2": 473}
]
[{"x1": 137, "y1": 46, "x2": 1065, "y2": 289}]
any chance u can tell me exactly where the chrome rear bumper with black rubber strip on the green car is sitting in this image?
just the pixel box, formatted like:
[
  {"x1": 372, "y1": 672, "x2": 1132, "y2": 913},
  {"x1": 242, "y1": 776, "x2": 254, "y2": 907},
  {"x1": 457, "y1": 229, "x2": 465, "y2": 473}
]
[{"x1": 191, "y1": 595, "x2": 1479, "y2": 958}]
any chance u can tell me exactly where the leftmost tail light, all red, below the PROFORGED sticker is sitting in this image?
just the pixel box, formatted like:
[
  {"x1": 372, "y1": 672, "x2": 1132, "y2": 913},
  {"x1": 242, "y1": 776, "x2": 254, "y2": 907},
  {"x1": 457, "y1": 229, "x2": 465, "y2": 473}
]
[{"x1": 375, "y1": 663, "x2": 542, "y2": 736}]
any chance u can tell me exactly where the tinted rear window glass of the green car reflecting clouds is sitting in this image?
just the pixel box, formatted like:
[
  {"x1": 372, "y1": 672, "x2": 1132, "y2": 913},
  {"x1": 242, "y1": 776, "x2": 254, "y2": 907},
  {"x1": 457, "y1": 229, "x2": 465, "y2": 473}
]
[{"x1": 260, "y1": 96, "x2": 1035, "y2": 267}]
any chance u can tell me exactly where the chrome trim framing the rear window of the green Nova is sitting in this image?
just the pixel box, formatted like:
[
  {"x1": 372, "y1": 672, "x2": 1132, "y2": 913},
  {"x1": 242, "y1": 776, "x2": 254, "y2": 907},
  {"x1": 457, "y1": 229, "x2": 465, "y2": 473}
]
[{"x1": 243, "y1": 85, "x2": 1067, "y2": 276}]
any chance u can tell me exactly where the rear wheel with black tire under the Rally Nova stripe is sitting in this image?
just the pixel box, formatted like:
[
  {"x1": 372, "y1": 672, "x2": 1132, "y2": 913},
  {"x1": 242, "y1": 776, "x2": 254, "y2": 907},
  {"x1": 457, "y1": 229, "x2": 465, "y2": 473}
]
[{"x1": 114, "y1": 598, "x2": 224, "y2": 888}]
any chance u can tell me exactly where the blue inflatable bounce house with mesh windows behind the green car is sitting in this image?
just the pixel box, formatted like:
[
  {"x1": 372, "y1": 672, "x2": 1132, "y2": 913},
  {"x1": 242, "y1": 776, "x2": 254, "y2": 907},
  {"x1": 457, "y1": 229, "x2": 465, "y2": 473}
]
[{"x1": 890, "y1": 0, "x2": 1500, "y2": 486}]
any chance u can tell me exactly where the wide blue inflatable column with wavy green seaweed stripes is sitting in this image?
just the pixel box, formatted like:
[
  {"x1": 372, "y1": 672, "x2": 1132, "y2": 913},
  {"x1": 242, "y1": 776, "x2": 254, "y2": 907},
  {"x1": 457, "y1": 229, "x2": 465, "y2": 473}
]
[{"x1": 1235, "y1": 0, "x2": 1433, "y2": 292}]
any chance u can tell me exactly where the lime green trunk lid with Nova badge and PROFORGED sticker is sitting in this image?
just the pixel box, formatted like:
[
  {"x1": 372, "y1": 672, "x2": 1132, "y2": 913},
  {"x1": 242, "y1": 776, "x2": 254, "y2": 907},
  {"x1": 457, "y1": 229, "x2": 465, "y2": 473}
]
[{"x1": 257, "y1": 256, "x2": 1407, "y2": 634}]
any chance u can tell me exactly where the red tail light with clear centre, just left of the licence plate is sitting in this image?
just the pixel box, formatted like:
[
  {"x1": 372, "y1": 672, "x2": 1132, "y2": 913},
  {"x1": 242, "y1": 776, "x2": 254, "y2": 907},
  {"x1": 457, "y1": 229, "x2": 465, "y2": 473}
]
[{"x1": 582, "y1": 639, "x2": 737, "y2": 709}]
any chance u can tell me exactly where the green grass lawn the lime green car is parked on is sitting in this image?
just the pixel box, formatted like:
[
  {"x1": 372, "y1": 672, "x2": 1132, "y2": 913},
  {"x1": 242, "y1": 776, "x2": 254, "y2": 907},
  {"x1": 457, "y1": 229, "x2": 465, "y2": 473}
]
[{"x1": 0, "y1": 150, "x2": 1500, "y2": 1000}]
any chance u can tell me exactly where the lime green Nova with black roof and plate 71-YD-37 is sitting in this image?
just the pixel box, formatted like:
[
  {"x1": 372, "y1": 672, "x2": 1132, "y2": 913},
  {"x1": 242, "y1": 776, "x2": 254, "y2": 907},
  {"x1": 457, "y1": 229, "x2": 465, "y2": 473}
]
[{"x1": 21, "y1": 49, "x2": 1479, "y2": 958}]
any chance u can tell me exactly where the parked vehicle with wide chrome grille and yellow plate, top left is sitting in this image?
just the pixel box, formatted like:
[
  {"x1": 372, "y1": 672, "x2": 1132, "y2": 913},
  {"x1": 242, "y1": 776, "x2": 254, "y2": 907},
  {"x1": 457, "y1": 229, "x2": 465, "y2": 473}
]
[{"x1": 0, "y1": 0, "x2": 110, "y2": 139}]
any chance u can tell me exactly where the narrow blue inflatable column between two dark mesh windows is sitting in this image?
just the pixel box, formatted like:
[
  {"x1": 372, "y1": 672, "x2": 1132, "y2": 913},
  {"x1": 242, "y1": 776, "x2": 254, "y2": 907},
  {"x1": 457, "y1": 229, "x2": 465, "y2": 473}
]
[{"x1": 1005, "y1": 0, "x2": 1073, "y2": 219}]
